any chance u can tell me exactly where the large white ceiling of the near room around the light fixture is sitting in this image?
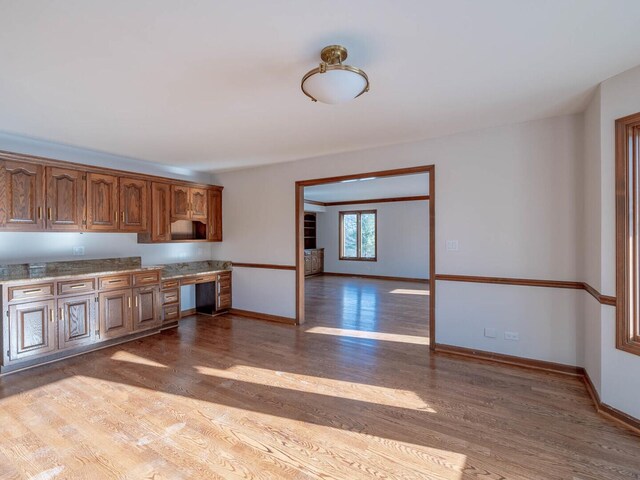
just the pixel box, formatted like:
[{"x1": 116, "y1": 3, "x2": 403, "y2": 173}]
[{"x1": 0, "y1": 0, "x2": 640, "y2": 171}]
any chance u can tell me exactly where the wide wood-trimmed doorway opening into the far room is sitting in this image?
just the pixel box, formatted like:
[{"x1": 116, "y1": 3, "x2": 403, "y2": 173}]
[{"x1": 295, "y1": 165, "x2": 436, "y2": 350}]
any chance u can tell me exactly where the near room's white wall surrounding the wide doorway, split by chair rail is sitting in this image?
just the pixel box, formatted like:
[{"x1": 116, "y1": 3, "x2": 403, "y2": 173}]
[{"x1": 213, "y1": 115, "x2": 583, "y2": 364}]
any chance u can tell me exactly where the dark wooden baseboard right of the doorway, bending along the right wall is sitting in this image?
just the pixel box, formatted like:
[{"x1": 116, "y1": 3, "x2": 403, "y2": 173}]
[{"x1": 434, "y1": 343, "x2": 640, "y2": 433}]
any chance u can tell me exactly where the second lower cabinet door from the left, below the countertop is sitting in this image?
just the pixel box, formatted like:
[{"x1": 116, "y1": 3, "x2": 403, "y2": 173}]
[{"x1": 58, "y1": 295, "x2": 96, "y2": 349}]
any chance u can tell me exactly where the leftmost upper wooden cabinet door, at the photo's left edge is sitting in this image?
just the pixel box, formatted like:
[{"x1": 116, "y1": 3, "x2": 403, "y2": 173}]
[{"x1": 0, "y1": 160, "x2": 44, "y2": 231}]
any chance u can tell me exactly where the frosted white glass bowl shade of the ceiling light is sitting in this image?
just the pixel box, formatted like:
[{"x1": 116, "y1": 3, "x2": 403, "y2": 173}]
[{"x1": 302, "y1": 65, "x2": 369, "y2": 104}]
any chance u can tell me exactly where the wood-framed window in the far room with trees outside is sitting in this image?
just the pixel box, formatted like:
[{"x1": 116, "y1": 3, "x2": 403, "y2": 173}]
[{"x1": 340, "y1": 210, "x2": 376, "y2": 260}]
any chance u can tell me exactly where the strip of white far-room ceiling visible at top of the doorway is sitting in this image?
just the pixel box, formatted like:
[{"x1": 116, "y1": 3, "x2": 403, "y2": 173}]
[{"x1": 304, "y1": 173, "x2": 429, "y2": 202}]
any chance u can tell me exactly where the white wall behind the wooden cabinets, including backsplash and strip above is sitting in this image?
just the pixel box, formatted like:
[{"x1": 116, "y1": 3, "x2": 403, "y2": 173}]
[{"x1": 0, "y1": 134, "x2": 211, "y2": 309}]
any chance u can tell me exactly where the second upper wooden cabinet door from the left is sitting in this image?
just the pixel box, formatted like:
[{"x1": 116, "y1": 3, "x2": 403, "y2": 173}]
[{"x1": 45, "y1": 167, "x2": 86, "y2": 231}]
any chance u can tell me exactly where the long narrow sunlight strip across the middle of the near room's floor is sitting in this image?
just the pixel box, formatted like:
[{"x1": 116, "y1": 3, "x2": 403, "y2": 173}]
[{"x1": 194, "y1": 365, "x2": 437, "y2": 413}]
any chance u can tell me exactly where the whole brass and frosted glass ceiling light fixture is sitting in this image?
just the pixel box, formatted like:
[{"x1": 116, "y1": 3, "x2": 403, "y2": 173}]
[{"x1": 301, "y1": 45, "x2": 369, "y2": 104}]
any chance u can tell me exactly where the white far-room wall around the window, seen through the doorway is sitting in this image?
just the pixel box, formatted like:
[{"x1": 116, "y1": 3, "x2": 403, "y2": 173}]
[{"x1": 316, "y1": 201, "x2": 429, "y2": 279}]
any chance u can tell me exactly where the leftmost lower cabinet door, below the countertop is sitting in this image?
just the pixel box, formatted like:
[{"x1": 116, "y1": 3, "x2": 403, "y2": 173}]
[{"x1": 9, "y1": 300, "x2": 57, "y2": 361}]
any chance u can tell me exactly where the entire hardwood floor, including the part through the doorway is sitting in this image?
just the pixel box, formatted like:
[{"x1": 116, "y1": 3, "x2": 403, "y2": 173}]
[{"x1": 0, "y1": 277, "x2": 640, "y2": 480}]
